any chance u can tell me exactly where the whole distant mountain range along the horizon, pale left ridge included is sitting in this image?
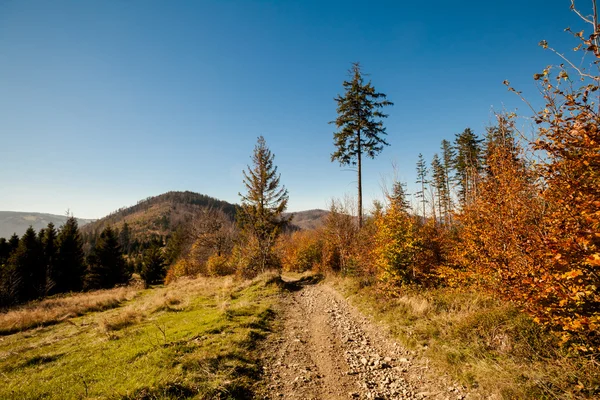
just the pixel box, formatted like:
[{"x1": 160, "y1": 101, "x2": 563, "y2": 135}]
[{"x1": 0, "y1": 191, "x2": 329, "y2": 240}]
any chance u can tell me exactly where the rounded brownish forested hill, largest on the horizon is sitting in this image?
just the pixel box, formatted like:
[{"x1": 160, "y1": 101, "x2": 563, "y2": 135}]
[{"x1": 82, "y1": 191, "x2": 236, "y2": 240}]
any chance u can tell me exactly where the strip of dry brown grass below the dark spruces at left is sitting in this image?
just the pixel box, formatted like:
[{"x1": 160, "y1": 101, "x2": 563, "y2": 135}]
[{"x1": 0, "y1": 287, "x2": 139, "y2": 335}]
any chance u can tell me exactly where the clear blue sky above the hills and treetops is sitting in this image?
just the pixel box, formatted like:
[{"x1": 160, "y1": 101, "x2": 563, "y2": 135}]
[{"x1": 0, "y1": 0, "x2": 589, "y2": 218}]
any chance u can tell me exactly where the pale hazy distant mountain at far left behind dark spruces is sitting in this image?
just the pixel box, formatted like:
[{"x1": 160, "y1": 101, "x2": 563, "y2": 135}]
[{"x1": 0, "y1": 211, "x2": 94, "y2": 239}]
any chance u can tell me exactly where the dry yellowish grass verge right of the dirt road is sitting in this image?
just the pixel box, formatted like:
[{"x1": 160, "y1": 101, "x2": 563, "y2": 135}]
[{"x1": 330, "y1": 277, "x2": 600, "y2": 399}]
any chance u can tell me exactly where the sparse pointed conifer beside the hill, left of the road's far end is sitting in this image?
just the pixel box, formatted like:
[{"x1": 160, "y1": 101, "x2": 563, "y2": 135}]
[{"x1": 238, "y1": 136, "x2": 290, "y2": 274}]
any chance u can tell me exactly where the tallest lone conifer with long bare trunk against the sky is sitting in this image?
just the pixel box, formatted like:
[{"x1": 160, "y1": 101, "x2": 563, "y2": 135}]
[{"x1": 331, "y1": 63, "x2": 393, "y2": 227}]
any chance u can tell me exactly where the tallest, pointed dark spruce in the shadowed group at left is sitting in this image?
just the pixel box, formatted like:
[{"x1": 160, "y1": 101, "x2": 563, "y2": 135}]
[{"x1": 51, "y1": 217, "x2": 85, "y2": 293}]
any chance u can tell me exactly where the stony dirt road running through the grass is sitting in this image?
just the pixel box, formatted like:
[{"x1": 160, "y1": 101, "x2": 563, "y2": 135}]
[{"x1": 259, "y1": 283, "x2": 466, "y2": 400}]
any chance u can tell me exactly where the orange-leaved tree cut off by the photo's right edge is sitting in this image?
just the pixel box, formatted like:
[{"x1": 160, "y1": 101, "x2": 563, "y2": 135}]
[{"x1": 520, "y1": 11, "x2": 600, "y2": 351}]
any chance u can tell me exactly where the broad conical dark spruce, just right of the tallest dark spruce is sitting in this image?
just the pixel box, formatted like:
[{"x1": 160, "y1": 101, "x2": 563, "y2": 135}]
[{"x1": 85, "y1": 226, "x2": 129, "y2": 289}]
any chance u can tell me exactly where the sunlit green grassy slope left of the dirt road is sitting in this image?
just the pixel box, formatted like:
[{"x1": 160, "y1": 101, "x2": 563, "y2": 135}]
[{"x1": 0, "y1": 277, "x2": 280, "y2": 400}]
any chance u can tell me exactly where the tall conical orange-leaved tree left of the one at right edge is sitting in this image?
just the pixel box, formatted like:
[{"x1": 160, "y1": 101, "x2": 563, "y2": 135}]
[{"x1": 453, "y1": 117, "x2": 544, "y2": 305}]
